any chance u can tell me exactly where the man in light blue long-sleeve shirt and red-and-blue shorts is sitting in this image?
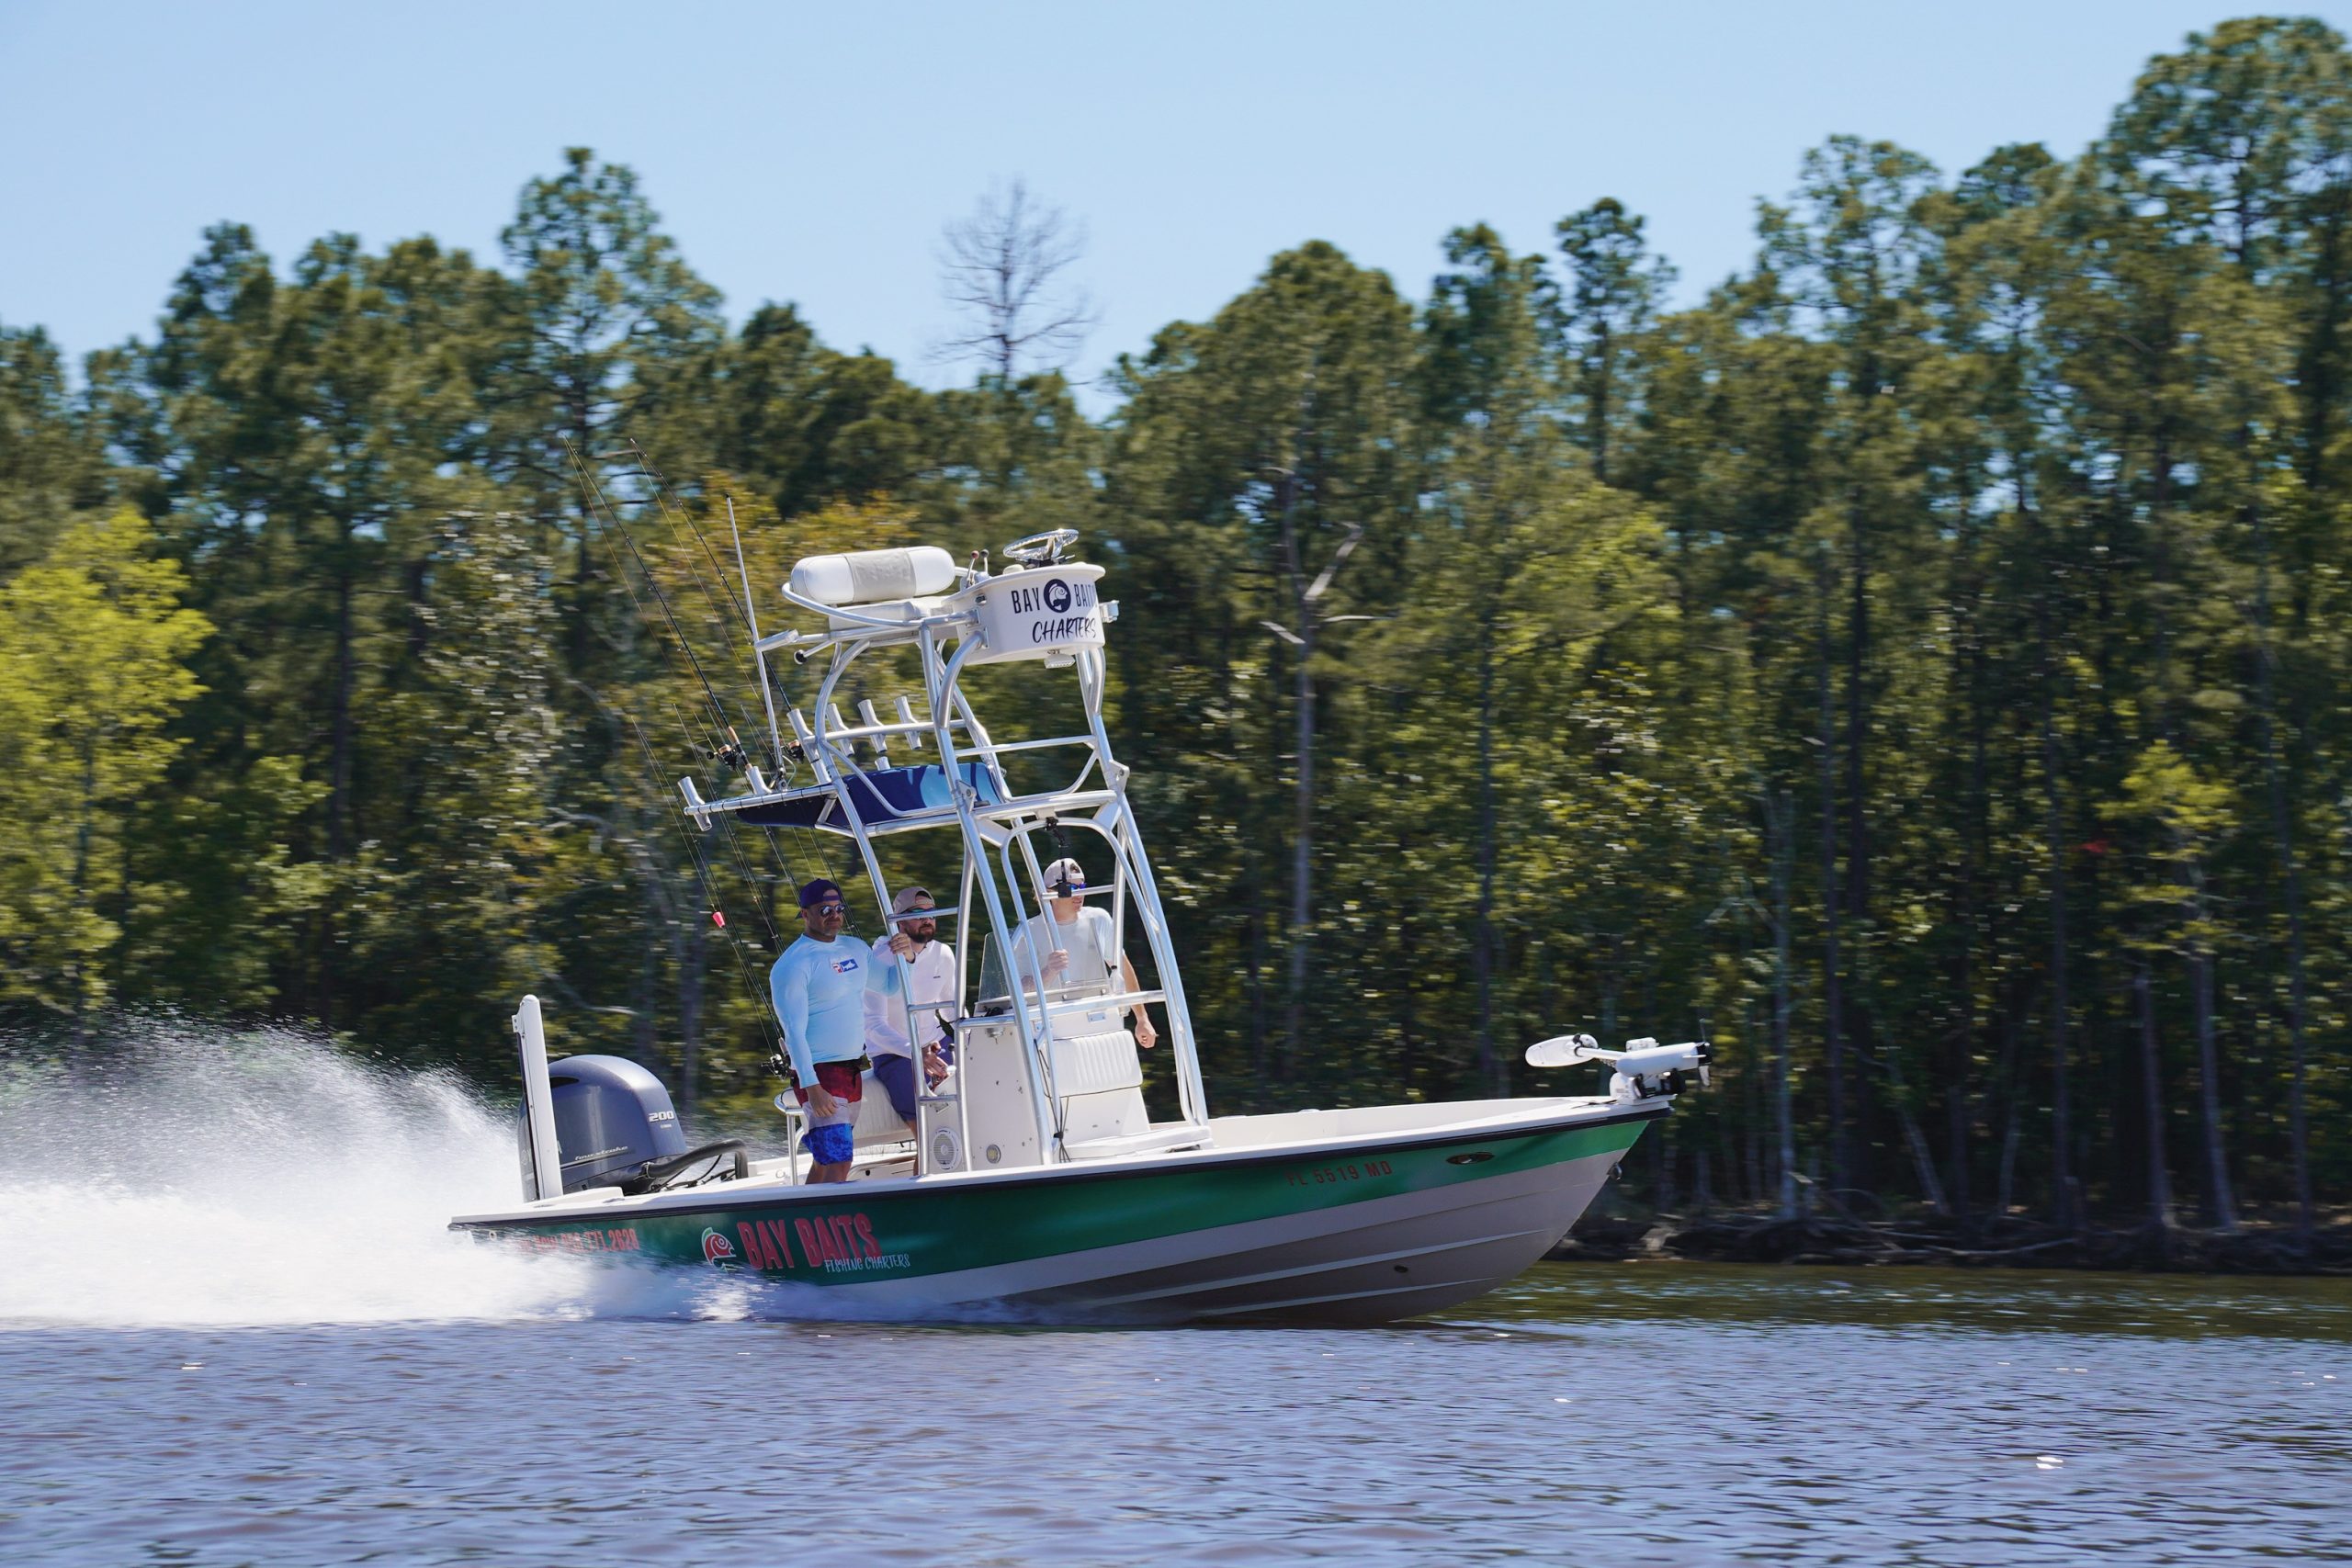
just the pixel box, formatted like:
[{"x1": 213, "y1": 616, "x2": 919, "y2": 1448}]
[{"x1": 767, "y1": 877, "x2": 915, "y2": 1182}]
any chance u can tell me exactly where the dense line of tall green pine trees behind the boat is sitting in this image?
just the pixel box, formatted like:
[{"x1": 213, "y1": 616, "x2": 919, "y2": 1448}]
[{"x1": 0, "y1": 18, "x2": 2352, "y2": 1227}]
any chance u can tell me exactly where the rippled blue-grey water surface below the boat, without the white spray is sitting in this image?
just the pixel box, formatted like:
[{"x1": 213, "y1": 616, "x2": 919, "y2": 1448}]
[{"x1": 0, "y1": 1265, "x2": 2352, "y2": 1563}]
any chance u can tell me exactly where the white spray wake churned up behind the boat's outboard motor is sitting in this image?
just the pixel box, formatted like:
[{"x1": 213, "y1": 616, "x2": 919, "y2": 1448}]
[{"x1": 0, "y1": 1021, "x2": 793, "y2": 1328}]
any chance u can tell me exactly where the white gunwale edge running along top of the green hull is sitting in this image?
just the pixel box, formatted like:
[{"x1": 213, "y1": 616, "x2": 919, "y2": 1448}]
[{"x1": 449, "y1": 1096, "x2": 1677, "y2": 1232}]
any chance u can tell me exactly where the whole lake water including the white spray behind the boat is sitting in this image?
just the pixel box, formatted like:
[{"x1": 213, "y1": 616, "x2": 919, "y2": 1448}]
[{"x1": 0, "y1": 1037, "x2": 2352, "y2": 1565}]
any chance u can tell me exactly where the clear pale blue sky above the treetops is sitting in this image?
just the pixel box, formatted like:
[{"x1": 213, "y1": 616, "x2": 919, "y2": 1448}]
[{"x1": 0, "y1": 0, "x2": 2352, "y2": 404}]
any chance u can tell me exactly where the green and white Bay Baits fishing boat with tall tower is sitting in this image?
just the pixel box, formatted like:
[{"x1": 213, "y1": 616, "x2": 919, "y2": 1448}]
[{"x1": 452, "y1": 529, "x2": 1710, "y2": 1324}]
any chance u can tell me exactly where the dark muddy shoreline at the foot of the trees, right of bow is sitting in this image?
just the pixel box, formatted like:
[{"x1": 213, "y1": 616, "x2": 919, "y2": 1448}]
[{"x1": 1545, "y1": 1208, "x2": 2352, "y2": 1277}]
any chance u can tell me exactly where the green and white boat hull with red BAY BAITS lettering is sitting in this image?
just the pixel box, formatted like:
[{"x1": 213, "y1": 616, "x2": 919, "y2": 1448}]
[{"x1": 454, "y1": 1102, "x2": 1665, "y2": 1321}]
